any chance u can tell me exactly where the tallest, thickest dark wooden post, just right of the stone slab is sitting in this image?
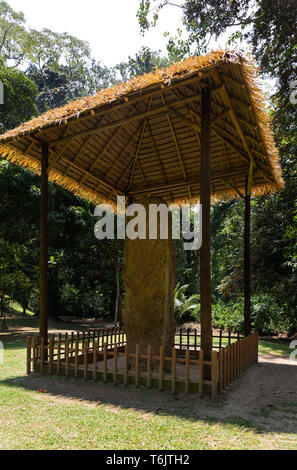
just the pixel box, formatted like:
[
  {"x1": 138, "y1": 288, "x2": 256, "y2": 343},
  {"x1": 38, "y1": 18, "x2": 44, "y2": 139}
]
[{"x1": 200, "y1": 88, "x2": 212, "y2": 379}]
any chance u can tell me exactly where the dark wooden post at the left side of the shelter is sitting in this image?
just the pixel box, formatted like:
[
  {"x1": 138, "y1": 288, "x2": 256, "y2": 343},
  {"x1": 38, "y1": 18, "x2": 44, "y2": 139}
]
[{"x1": 39, "y1": 143, "x2": 49, "y2": 345}]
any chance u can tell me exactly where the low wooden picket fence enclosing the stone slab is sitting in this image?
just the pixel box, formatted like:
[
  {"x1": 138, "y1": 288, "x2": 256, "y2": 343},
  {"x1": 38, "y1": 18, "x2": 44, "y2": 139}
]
[{"x1": 27, "y1": 328, "x2": 258, "y2": 400}]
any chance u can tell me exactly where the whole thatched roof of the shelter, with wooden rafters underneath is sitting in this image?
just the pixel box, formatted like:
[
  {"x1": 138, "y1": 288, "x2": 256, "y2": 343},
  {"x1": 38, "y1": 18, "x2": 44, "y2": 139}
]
[{"x1": 0, "y1": 51, "x2": 283, "y2": 204}]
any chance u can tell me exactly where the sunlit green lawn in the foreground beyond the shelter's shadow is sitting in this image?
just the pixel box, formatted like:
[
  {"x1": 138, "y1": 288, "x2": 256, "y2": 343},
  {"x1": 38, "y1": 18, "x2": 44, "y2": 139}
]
[{"x1": 0, "y1": 319, "x2": 296, "y2": 450}]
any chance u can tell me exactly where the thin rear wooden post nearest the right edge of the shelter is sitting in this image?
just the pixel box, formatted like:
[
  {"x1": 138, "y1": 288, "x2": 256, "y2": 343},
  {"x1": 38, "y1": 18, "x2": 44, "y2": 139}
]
[{"x1": 244, "y1": 178, "x2": 251, "y2": 336}]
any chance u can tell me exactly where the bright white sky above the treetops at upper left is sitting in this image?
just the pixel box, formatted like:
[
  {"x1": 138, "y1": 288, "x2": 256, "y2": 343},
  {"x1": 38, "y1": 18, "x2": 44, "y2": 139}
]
[{"x1": 8, "y1": 0, "x2": 185, "y2": 66}]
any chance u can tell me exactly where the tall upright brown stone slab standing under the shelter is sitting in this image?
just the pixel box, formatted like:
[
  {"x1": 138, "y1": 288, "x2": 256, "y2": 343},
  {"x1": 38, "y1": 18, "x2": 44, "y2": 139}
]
[{"x1": 124, "y1": 197, "x2": 176, "y2": 355}]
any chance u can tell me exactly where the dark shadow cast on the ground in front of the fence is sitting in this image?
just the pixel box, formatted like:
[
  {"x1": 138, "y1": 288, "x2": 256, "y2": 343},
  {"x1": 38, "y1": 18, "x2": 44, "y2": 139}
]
[{"x1": 0, "y1": 363, "x2": 297, "y2": 434}]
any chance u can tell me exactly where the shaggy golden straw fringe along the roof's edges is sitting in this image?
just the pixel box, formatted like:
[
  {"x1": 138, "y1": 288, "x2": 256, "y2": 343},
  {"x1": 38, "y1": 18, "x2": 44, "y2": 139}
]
[{"x1": 0, "y1": 50, "x2": 284, "y2": 210}]
